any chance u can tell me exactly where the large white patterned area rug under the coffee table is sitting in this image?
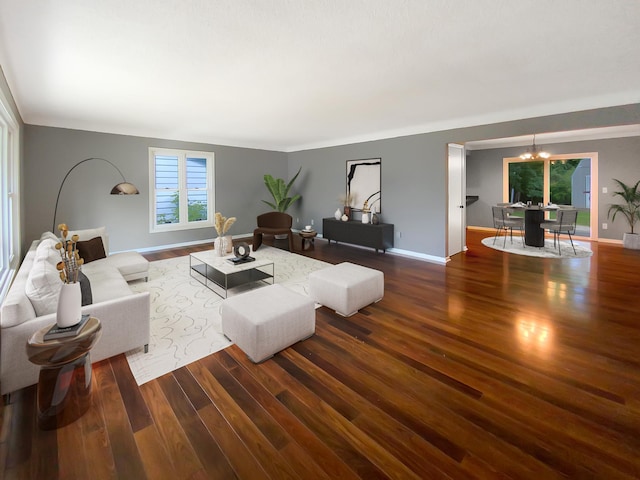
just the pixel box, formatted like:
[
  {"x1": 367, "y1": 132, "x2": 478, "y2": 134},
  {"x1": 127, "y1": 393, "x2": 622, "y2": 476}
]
[{"x1": 126, "y1": 246, "x2": 331, "y2": 385}]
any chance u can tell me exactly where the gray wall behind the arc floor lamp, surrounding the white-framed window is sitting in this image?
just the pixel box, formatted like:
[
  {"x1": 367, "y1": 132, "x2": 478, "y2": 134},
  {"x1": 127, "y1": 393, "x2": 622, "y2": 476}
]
[{"x1": 23, "y1": 125, "x2": 286, "y2": 251}]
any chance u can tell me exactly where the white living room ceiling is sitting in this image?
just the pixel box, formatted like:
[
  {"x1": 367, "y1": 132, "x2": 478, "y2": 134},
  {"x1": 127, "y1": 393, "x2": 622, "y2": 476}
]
[{"x1": 0, "y1": 0, "x2": 640, "y2": 151}]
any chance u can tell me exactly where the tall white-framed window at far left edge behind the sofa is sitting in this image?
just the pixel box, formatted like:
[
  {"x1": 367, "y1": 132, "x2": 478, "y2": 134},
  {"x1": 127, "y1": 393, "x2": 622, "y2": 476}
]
[{"x1": 0, "y1": 86, "x2": 20, "y2": 301}]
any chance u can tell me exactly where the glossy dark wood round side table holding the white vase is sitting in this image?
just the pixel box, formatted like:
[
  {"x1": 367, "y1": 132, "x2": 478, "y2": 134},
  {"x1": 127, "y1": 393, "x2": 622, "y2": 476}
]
[{"x1": 27, "y1": 317, "x2": 102, "y2": 430}]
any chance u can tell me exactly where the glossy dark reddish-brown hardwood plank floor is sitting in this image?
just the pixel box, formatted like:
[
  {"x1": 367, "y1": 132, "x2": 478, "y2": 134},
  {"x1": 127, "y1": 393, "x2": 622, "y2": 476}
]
[{"x1": 0, "y1": 231, "x2": 640, "y2": 480}]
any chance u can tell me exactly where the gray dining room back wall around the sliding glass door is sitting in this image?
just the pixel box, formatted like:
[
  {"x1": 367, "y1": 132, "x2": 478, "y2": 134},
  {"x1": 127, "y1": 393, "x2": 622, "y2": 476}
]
[{"x1": 467, "y1": 137, "x2": 640, "y2": 240}]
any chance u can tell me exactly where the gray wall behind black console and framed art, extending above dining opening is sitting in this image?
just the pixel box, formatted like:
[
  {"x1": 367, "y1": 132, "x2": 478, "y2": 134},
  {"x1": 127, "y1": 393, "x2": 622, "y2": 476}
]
[{"x1": 289, "y1": 104, "x2": 640, "y2": 258}]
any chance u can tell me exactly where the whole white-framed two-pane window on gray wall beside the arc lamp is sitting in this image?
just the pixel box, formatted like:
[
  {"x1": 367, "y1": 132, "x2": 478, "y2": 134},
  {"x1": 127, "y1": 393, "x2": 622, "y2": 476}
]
[{"x1": 149, "y1": 148, "x2": 215, "y2": 232}]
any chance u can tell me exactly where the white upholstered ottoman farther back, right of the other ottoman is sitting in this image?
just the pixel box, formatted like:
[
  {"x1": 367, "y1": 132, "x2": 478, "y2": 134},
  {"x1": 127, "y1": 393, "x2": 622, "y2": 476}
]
[{"x1": 309, "y1": 262, "x2": 384, "y2": 317}]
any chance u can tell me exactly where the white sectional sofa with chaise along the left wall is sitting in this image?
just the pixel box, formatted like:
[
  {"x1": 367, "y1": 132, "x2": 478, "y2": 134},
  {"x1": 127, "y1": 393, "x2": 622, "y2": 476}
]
[{"x1": 0, "y1": 228, "x2": 150, "y2": 395}]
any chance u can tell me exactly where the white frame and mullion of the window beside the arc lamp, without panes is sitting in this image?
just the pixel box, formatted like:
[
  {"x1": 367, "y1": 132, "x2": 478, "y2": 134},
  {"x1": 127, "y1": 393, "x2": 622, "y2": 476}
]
[{"x1": 149, "y1": 147, "x2": 215, "y2": 233}]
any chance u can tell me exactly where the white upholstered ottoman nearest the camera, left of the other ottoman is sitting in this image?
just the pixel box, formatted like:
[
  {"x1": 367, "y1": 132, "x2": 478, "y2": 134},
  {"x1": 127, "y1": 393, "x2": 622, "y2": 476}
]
[{"x1": 220, "y1": 283, "x2": 316, "y2": 363}]
